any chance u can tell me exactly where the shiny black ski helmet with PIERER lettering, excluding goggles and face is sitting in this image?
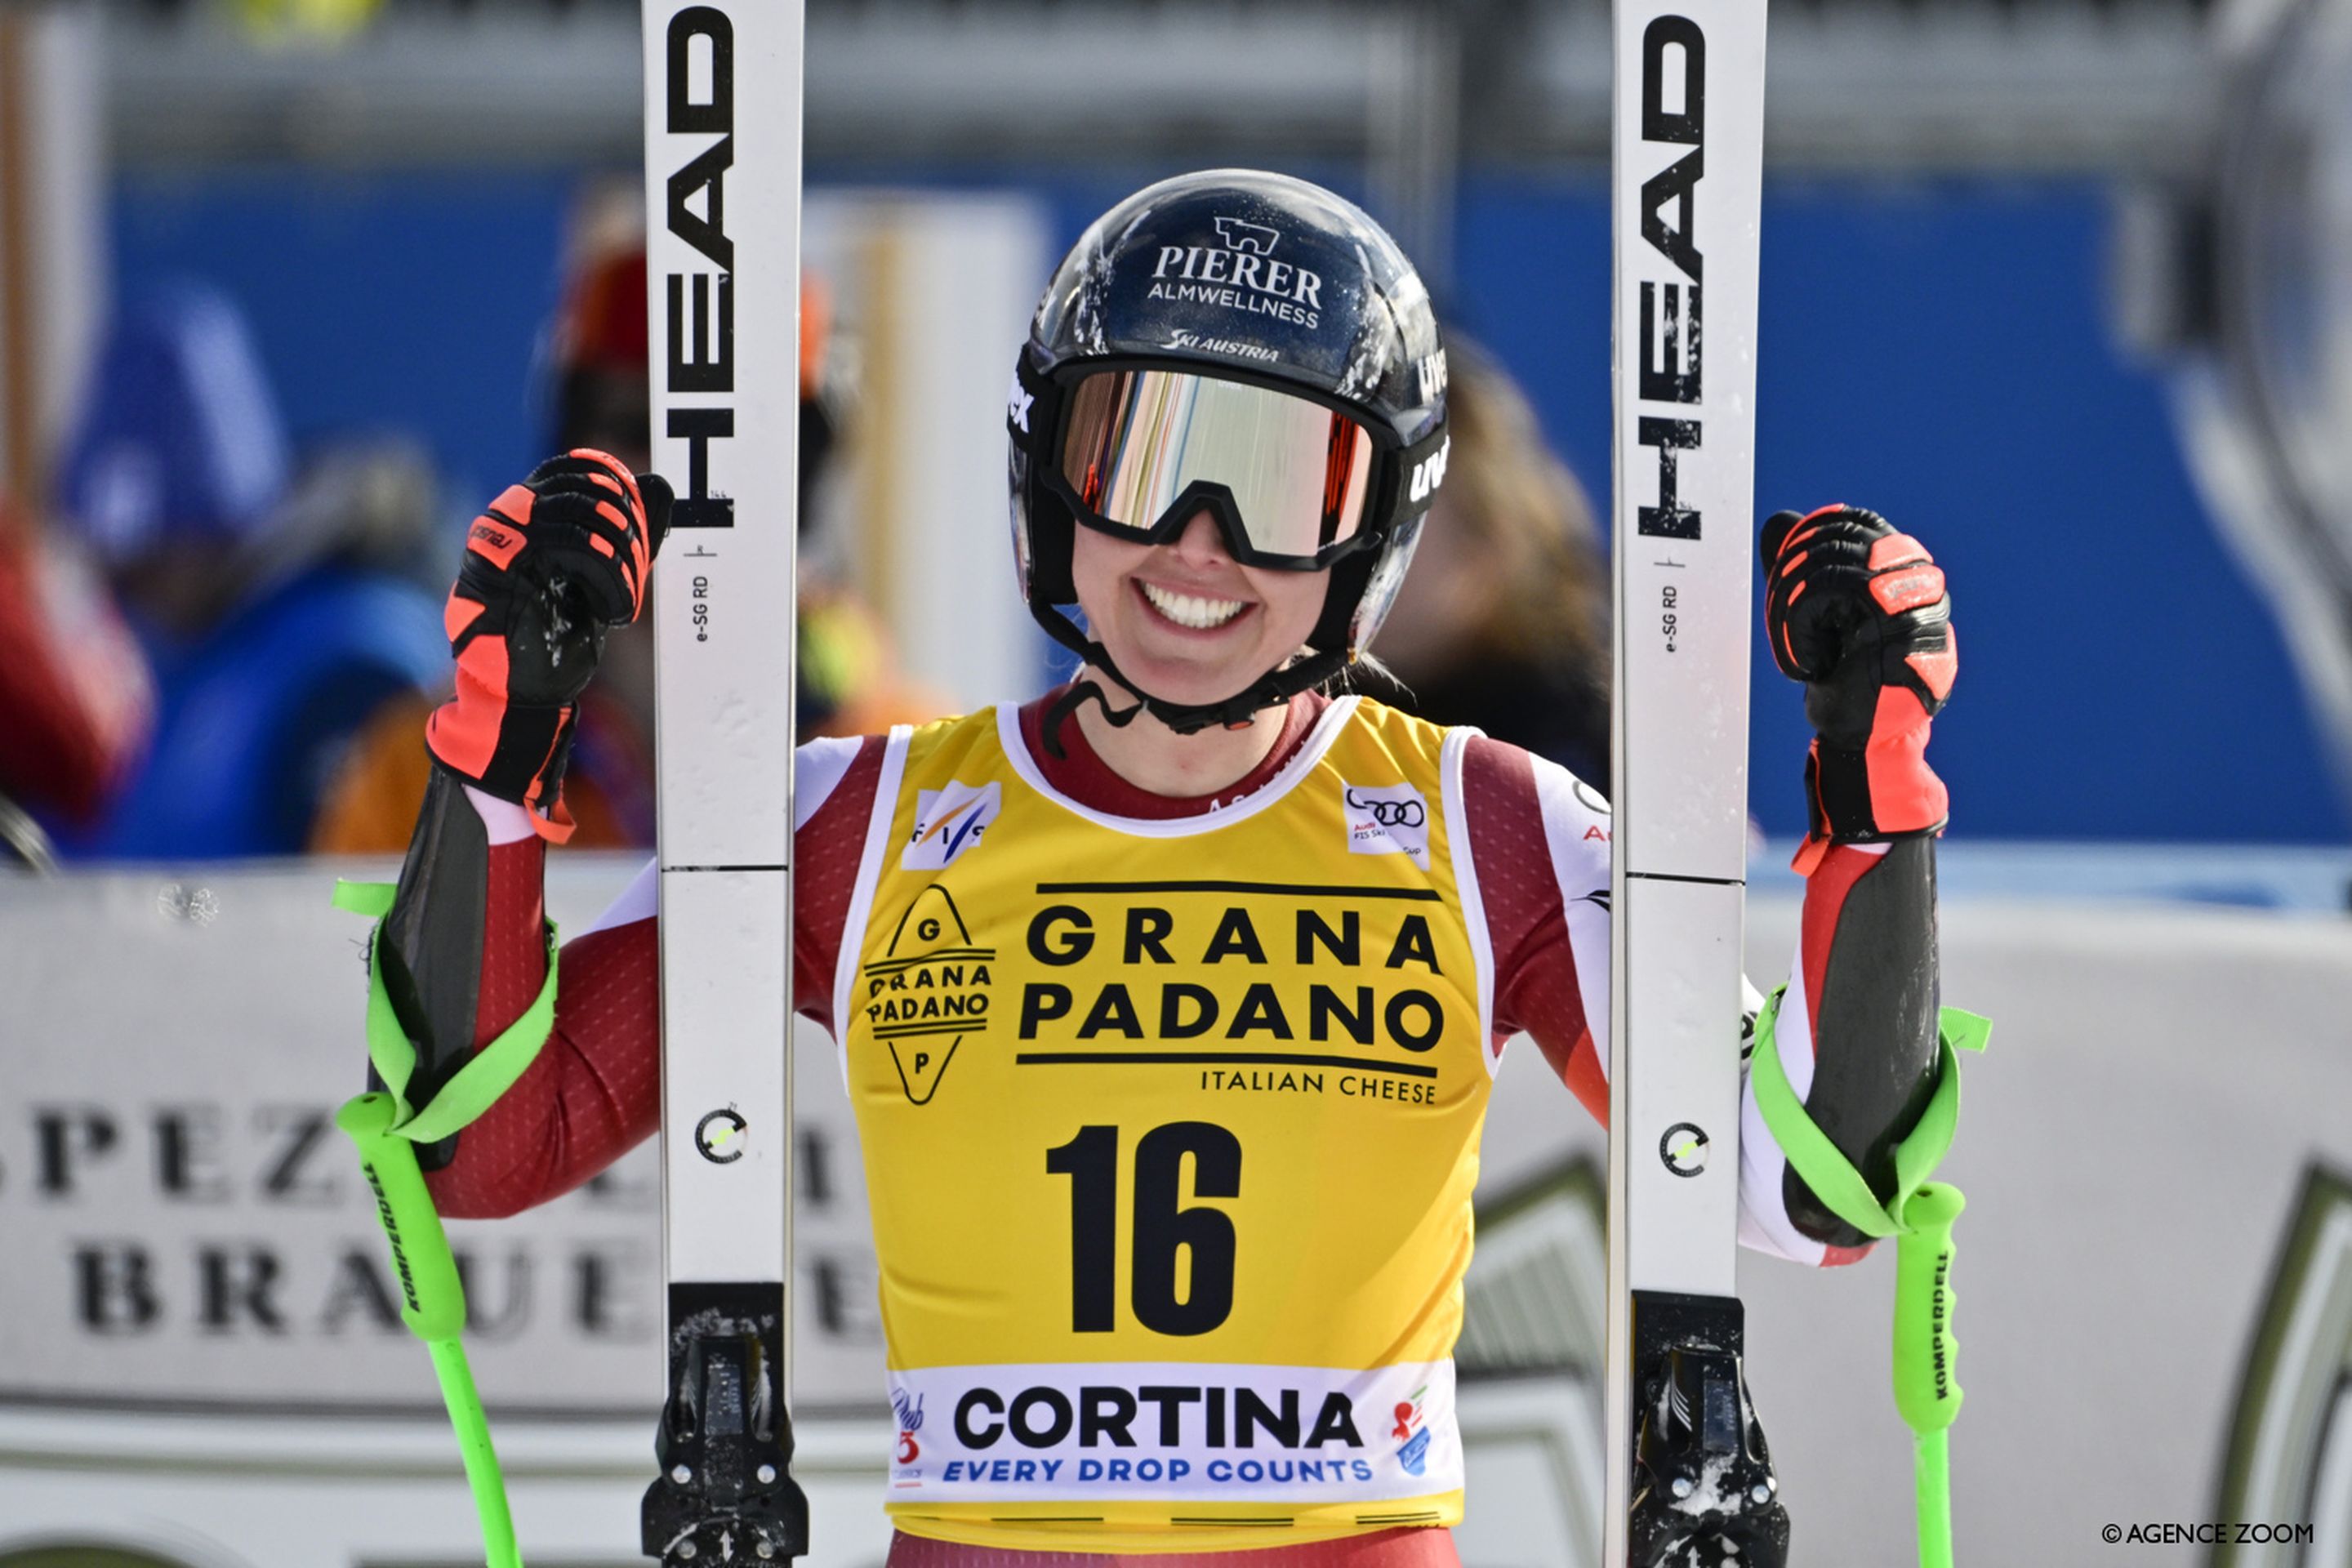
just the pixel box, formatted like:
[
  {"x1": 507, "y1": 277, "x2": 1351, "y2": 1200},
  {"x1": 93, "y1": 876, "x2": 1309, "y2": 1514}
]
[{"x1": 1007, "y1": 169, "x2": 1446, "y2": 731}]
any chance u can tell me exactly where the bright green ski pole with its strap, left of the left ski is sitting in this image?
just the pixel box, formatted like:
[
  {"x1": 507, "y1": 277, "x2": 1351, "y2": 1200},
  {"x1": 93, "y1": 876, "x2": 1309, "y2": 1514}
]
[{"x1": 334, "y1": 881, "x2": 555, "y2": 1568}]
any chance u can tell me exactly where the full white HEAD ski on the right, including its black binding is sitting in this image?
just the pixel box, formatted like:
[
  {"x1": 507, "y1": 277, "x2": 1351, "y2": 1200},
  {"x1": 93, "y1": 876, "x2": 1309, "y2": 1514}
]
[{"x1": 1601, "y1": 0, "x2": 1788, "y2": 1568}]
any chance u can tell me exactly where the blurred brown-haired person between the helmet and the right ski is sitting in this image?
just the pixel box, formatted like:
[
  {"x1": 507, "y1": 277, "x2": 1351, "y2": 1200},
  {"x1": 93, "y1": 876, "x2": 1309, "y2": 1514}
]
[{"x1": 1352, "y1": 336, "x2": 1609, "y2": 787}]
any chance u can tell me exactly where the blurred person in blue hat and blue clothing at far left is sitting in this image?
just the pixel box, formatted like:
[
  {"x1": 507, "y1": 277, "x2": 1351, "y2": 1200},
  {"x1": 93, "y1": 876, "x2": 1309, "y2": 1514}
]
[{"x1": 46, "y1": 282, "x2": 449, "y2": 858}]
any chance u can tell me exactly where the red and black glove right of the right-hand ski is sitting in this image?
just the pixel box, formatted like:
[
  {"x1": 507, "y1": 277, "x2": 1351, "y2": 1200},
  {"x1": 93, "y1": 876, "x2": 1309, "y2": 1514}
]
[{"x1": 1764, "y1": 506, "x2": 1959, "y2": 870}]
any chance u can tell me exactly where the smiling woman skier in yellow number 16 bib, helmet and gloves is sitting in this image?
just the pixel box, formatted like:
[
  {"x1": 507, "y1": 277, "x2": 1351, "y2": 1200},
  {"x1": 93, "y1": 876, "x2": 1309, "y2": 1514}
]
[{"x1": 383, "y1": 169, "x2": 1952, "y2": 1568}]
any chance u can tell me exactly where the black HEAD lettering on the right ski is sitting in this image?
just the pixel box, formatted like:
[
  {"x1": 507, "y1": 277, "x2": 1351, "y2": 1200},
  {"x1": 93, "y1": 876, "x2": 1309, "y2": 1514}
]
[{"x1": 1635, "y1": 16, "x2": 1708, "y2": 538}]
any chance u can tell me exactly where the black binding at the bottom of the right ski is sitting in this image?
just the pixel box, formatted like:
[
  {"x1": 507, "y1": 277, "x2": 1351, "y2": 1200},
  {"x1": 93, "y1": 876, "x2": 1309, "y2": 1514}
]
[{"x1": 1628, "y1": 1290, "x2": 1788, "y2": 1568}]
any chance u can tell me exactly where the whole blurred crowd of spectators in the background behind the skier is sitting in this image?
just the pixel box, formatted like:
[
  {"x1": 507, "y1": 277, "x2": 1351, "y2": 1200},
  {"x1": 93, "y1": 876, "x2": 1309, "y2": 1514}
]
[{"x1": 0, "y1": 207, "x2": 1609, "y2": 867}]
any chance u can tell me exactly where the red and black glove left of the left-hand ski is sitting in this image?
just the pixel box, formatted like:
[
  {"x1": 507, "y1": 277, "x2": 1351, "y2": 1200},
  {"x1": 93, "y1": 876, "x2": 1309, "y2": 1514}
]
[{"x1": 425, "y1": 447, "x2": 670, "y2": 844}]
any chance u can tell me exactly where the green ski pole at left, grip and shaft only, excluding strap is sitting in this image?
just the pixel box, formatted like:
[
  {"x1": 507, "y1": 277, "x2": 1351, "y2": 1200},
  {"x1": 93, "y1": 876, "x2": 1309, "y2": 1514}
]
[{"x1": 334, "y1": 1094, "x2": 522, "y2": 1568}]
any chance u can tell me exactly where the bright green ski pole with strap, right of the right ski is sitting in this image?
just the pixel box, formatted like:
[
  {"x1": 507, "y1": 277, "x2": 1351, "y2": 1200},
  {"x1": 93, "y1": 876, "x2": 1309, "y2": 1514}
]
[{"x1": 1748, "y1": 987, "x2": 1992, "y2": 1568}]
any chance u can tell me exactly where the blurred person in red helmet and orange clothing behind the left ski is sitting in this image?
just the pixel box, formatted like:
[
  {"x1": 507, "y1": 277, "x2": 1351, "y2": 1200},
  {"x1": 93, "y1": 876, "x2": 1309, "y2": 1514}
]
[{"x1": 313, "y1": 238, "x2": 946, "y2": 853}]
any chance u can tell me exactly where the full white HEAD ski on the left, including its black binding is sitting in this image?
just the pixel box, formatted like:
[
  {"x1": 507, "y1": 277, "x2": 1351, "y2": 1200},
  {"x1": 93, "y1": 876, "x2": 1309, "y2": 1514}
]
[{"x1": 642, "y1": 0, "x2": 809, "y2": 1568}]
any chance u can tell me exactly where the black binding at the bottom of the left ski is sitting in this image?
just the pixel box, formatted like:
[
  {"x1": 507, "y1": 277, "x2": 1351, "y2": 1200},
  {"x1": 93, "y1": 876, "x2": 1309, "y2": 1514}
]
[{"x1": 639, "y1": 1281, "x2": 809, "y2": 1568}]
